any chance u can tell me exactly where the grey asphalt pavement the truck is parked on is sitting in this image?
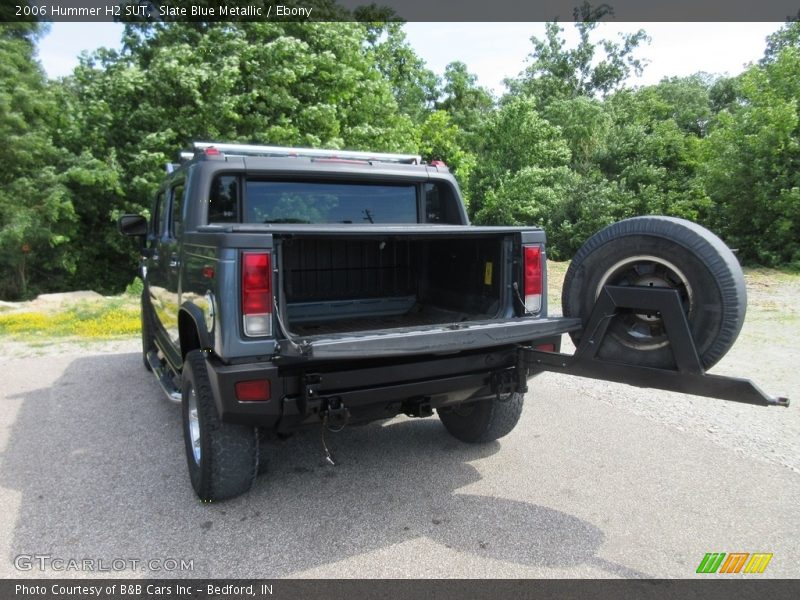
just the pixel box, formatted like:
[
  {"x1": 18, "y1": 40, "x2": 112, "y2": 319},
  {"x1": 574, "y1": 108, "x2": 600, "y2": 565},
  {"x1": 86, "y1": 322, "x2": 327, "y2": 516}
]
[{"x1": 0, "y1": 343, "x2": 800, "y2": 578}]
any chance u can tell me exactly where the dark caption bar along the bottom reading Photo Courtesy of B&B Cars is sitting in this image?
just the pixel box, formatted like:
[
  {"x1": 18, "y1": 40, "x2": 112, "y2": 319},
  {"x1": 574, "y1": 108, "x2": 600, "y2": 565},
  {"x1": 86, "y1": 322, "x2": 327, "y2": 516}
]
[{"x1": 0, "y1": 575, "x2": 800, "y2": 600}]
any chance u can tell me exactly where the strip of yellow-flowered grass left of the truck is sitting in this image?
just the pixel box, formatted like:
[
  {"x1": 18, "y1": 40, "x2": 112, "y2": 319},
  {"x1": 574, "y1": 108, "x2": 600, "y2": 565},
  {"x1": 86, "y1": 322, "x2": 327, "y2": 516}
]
[{"x1": 0, "y1": 298, "x2": 140, "y2": 340}]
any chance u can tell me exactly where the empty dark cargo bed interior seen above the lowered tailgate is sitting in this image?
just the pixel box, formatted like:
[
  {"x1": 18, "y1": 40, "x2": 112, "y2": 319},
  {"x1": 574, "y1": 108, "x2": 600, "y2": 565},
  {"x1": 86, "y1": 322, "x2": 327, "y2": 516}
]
[{"x1": 273, "y1": 228, "x2": 521, "y2": 335}]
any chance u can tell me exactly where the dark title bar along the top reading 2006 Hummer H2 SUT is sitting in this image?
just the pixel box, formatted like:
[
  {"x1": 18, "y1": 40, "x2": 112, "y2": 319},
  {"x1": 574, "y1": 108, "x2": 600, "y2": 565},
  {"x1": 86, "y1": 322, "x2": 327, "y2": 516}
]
[{"x1": 9, "y1": 0, "x2": 800, "y2": 23}]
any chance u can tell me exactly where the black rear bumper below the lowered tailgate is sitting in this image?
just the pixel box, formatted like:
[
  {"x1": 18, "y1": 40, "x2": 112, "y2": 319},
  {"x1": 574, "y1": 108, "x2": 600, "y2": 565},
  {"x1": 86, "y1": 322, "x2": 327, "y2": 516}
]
[{"x1": 208, "y1": 335, "x2": 561, "y2": 431}]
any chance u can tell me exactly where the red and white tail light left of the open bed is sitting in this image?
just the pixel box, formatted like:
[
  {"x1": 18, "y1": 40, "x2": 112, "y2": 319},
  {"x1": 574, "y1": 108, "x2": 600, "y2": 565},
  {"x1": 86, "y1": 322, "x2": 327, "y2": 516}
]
[{"x1": 242, "y1": 252, "x2": 272, "y2": 337}]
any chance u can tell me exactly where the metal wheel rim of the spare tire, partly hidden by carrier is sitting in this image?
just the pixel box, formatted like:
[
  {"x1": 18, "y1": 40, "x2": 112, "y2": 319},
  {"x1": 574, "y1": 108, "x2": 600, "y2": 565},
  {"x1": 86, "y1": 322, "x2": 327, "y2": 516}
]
[{"x1": 595, "y1": 256, "x2": 693, "y2": 350}]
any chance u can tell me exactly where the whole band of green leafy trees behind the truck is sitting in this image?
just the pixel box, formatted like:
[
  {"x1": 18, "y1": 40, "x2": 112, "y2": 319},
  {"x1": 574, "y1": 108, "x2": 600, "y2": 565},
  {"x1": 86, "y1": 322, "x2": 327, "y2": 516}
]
[{"x1": 0, "y1": 18, "x2": 800, "y2": 298}]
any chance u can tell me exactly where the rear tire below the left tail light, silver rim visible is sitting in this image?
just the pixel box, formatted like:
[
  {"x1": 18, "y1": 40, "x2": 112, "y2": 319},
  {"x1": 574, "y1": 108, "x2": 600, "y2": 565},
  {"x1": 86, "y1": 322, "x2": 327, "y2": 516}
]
[{"x1": 181, "y1": 350, "x2": 258, "y2": 502}]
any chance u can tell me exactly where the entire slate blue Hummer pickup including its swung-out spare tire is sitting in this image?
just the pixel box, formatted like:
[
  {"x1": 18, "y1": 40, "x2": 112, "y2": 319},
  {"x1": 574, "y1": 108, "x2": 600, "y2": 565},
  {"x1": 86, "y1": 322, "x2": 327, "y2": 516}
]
[{"x1": 119, "y1": 143, "x2": 788, "y2": 500}]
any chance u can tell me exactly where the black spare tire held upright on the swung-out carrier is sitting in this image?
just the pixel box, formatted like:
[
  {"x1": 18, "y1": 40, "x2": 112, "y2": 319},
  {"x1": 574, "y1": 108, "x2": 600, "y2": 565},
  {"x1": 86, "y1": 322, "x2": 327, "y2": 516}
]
[{"x1": 562, "y1": 216, "x2": 747, "y2": 369}]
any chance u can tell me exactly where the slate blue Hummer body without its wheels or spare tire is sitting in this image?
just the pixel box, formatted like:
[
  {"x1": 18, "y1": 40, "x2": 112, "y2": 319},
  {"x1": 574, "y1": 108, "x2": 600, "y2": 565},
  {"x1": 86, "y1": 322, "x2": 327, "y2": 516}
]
[{"x1": 136, "y1": 145, "x2": 579, "y2": 430}]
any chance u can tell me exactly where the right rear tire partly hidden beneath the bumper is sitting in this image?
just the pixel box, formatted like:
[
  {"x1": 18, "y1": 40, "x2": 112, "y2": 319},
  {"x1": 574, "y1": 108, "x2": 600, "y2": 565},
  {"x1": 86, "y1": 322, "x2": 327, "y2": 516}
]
[{"x1": 437, "y1": 392, "x2": 525, "y2": 444}]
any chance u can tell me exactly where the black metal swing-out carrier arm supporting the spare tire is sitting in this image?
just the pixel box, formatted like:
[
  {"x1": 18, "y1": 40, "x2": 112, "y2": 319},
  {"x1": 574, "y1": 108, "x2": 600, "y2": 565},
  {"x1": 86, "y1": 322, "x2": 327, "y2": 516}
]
[{"x1": 520, "y1": 286, "x2": 789, "y2": 406}]
